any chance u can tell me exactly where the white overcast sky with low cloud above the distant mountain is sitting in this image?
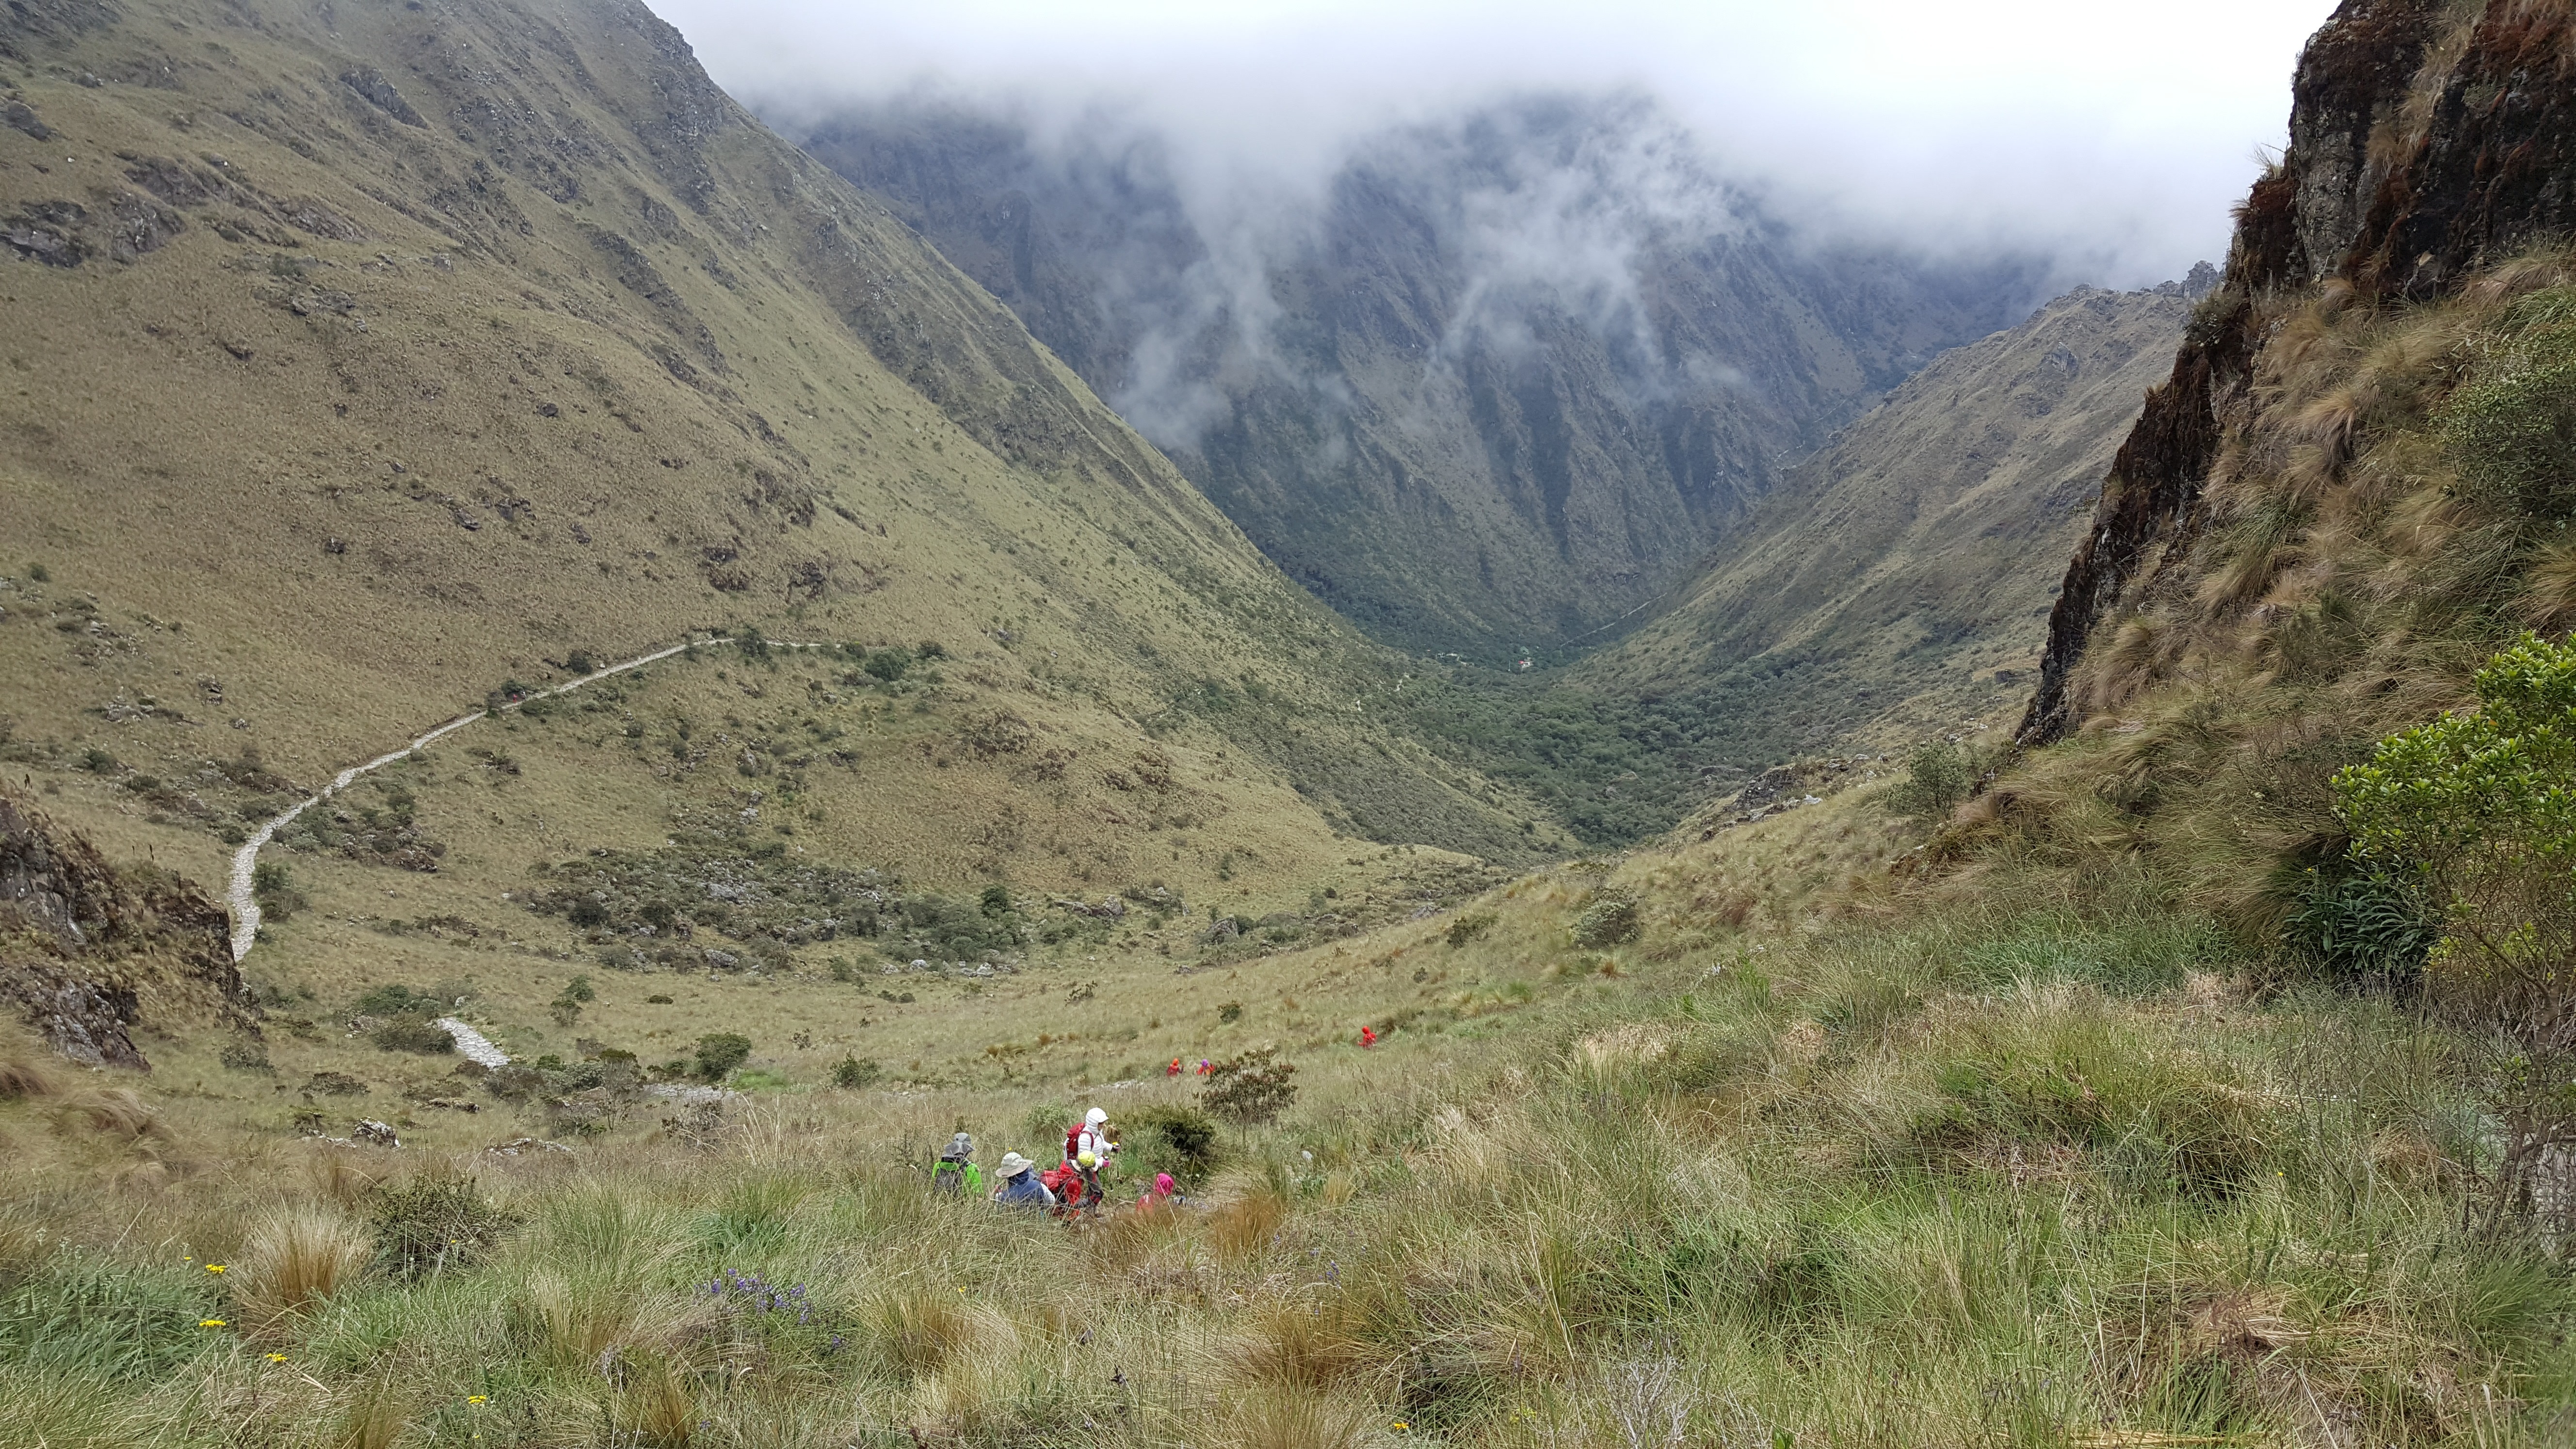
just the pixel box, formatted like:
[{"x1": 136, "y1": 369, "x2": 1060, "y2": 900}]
[{"x1": 649, "y1": 0, "x2": 2331, "y2": 284}]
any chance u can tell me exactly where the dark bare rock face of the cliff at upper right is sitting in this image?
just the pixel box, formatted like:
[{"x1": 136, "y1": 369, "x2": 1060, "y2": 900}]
[{"x1": 2020, "y1": 0, "x2": 2576, "y2": 745}]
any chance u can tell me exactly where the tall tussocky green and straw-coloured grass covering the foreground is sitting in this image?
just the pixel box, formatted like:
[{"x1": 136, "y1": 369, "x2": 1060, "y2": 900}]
[{"x1": 0, "y1": 876, "x2": 2576, "y2": 1447}]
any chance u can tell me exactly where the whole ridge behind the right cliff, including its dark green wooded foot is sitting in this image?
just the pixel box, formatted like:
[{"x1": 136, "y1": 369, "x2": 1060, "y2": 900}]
[{"x1": 1417, "y1": 277, "x2": 2210, "y2": 846}]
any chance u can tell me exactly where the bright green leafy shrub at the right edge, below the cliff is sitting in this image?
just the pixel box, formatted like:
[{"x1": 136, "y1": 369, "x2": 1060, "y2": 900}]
[{"x1": 2334, "y1": 634, "x2": 2576, "y2": 1220}]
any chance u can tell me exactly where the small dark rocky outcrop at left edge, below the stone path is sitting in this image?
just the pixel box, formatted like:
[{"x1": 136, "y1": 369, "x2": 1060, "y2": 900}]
[{"x1": 0, "y1": 794, "x2": 258, "y2": 1070}]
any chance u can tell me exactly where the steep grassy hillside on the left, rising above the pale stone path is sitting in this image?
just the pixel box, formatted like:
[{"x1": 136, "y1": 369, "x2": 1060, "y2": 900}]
[{"x1": 0, "y1": 2, "x2": 1541, "y2": 923}]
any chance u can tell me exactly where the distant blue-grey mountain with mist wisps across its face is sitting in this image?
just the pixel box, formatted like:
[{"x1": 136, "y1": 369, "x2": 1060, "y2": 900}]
[{"x1": 804, "y1": 98, "x2": 2035, "y2": 649}]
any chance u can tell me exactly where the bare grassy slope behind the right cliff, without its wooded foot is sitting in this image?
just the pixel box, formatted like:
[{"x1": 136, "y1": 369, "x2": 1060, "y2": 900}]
[{"x1": 1579, "y1": 281, "x2": 2213, "y2": 747}]
